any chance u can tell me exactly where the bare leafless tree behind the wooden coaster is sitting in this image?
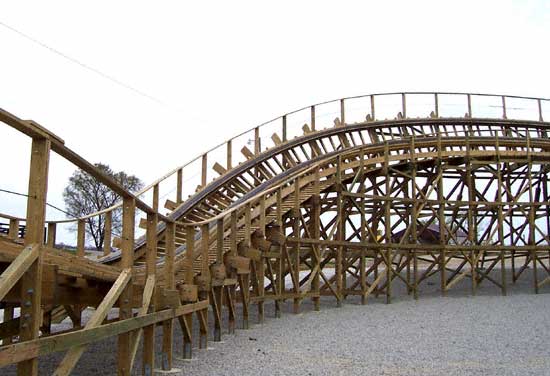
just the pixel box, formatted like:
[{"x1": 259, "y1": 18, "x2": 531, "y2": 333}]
[{"x1": 63, "y1": 163, "x2": 143, "y2": 250}]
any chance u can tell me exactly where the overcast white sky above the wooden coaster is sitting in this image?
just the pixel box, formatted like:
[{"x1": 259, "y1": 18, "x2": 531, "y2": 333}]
[{"x1": 0, "y1": 0, "x2": 550, "y2": 232}]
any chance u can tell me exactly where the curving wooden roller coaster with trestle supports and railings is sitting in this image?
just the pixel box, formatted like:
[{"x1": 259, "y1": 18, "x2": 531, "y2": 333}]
[{"x1": 0, "y1": 93, "x2": 550, "y2": 375}]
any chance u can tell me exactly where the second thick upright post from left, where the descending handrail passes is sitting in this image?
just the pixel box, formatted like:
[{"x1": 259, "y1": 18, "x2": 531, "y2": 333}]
[{"x1": 117, "y1": 197, "x2": 136, "y2": 375}]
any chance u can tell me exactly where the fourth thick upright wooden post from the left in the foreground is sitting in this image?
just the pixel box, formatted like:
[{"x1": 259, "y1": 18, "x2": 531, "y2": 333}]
[{"x1": 162, "y1": 222, "x2": 176, "y2": 371}]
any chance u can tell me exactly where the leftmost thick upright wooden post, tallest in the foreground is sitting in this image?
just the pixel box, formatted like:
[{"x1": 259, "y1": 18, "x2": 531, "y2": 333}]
[{"x1": 17, "y1": 138, "x2": 50, "y2": 376}]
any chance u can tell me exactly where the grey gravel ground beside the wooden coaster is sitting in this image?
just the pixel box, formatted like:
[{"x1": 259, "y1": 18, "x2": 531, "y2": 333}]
[{"x1": 0, "y1": 270, "x2": 550, "y2": 375}]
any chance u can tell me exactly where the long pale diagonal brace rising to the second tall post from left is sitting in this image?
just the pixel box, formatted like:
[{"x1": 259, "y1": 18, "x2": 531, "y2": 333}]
[{"x1": 53, "y1": 268, "x2": 132, "y2": 376}]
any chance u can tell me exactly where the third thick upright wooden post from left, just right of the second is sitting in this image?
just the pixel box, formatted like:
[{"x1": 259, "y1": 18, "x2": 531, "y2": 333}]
[{"x1": 143, "y1": 184, "x2": 159, "y2": 375}]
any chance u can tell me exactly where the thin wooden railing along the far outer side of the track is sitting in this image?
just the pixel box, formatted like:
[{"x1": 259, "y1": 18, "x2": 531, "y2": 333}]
[{"x1": 0, "y1": 92, "x2": 550, "y2": 255}]
